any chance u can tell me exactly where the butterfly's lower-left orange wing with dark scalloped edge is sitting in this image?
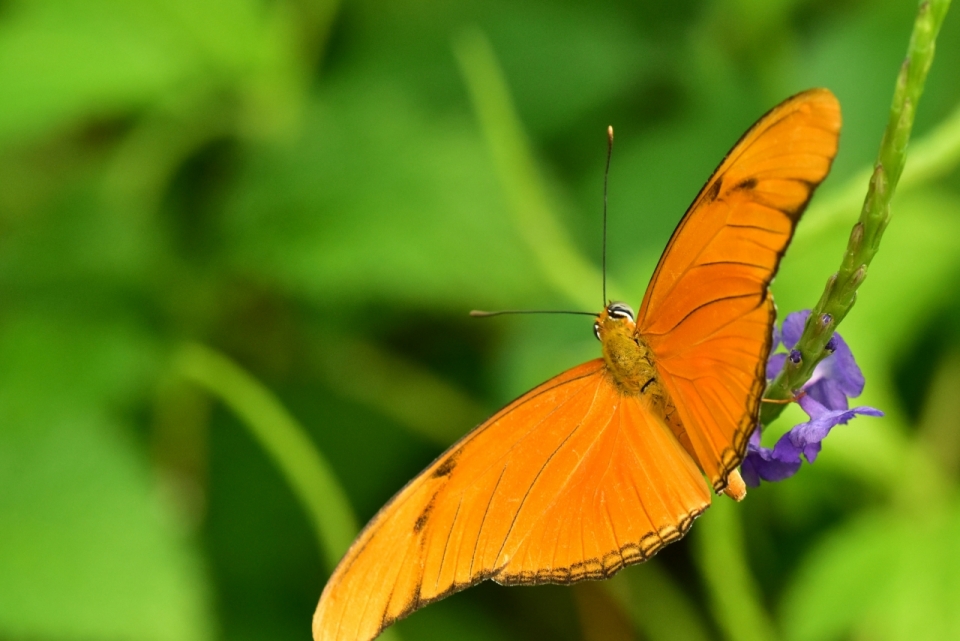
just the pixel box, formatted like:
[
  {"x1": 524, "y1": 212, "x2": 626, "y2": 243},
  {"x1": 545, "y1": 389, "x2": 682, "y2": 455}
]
[{"x1": 313, "y1": 359, "x2": 710, "y2": 641}]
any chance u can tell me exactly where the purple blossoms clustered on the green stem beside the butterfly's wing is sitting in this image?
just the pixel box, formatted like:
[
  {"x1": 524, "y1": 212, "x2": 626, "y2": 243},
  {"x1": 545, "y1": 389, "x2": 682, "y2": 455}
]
[{"x1": 740, "y1": 310, "x2": 883, "y2": 487}]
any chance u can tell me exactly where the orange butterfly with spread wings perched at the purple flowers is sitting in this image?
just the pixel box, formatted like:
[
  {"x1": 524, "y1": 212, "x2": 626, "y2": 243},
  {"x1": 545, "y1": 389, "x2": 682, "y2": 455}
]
[{"x1": 313, "y1": 89, "x2": 840, "y2": 641}]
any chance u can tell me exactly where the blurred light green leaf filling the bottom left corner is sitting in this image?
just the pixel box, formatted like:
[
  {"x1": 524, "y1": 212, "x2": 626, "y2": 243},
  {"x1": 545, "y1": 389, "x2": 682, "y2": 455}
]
[{"x1": 0, "y1": 412, "x2": 212, "y2": 641}]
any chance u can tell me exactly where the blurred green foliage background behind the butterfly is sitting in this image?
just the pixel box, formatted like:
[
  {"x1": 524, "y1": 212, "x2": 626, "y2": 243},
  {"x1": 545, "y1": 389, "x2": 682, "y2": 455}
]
[{"x1": 0, "y1": 0, "x2": 960, "y2": 641}]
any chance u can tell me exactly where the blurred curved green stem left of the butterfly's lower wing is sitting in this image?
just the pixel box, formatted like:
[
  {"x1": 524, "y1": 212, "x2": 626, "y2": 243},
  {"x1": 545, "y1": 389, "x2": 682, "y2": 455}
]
[{"x1": 174, "y1": 343, "x2": 359, "y2": 570}]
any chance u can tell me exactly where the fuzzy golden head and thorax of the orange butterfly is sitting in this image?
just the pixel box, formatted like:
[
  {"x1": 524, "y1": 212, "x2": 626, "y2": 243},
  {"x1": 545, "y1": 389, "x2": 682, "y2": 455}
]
[{"x1": 594, "y1": 303, "x2": 664, "y2": 399}]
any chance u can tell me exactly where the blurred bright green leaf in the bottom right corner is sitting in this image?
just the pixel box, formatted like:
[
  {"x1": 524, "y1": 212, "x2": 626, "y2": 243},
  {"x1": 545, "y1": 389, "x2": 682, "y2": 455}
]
[{"x1": 782, "y1": 501, "x2": 960, "y2": 641}]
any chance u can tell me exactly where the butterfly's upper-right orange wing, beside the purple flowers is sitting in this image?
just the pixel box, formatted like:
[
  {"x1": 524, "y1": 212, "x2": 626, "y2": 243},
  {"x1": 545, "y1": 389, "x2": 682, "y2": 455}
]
[{"x1": 637, "y1": 89, "x2": 840, "y2": 491}]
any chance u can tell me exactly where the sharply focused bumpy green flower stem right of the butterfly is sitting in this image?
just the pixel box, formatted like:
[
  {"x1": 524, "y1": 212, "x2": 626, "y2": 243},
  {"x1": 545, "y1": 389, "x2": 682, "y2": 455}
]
[{"x1": 760, "y1": 0, "x2": 950, "y2": 425}]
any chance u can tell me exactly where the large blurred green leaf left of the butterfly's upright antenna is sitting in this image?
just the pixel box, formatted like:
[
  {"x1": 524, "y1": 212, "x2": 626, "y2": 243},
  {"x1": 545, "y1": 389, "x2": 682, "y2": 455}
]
[{"x1": 223, "y1": 80, "x2": 537, "y2": 311}]
